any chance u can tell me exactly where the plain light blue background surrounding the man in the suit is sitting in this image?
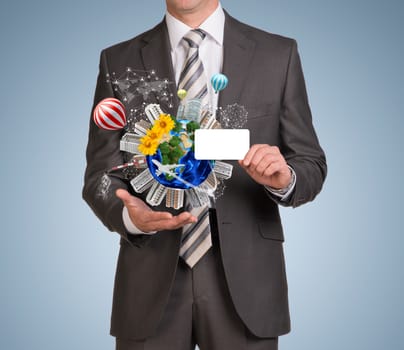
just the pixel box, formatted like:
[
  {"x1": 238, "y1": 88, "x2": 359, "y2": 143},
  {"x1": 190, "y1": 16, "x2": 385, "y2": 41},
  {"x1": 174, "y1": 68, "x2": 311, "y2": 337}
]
[{"x1": 0, "y1": 0, "x2": 404, "y2": 350}]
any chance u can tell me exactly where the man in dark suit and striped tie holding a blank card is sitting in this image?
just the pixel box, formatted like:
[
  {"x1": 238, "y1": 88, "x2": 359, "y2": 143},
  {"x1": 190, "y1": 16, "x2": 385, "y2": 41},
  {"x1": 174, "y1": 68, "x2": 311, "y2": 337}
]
[{"x1": 83, "y1": 0, "x2": 326, "y2": 350}]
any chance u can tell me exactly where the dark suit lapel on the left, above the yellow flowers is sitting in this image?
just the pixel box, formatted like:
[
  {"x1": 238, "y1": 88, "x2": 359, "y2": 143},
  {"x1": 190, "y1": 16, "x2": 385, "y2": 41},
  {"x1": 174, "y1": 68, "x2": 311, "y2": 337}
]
[{"x1": 141, "y1": 20, "x2": 179, "y2": 115}]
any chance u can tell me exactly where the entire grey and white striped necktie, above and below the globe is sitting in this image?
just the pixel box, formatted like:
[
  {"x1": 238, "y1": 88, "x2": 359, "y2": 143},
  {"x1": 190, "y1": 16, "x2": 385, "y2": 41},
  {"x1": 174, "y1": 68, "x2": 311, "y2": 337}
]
[{"x1": 178, "y1": 29, "x2": 212, "y2": 268}]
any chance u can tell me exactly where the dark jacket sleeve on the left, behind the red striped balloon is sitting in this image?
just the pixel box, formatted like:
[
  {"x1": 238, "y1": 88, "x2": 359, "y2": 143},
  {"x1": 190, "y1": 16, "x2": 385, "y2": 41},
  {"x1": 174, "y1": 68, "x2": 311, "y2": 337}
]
[{"x1": 83, "y1": 50, "x2": 148, "y2": 246}]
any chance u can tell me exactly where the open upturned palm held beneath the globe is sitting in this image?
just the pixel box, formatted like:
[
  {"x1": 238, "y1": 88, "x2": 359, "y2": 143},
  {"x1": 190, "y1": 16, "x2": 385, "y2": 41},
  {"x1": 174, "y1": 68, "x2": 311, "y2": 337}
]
[{"x1": 116, "y1": 189, "x2": 197, "y2": 232}]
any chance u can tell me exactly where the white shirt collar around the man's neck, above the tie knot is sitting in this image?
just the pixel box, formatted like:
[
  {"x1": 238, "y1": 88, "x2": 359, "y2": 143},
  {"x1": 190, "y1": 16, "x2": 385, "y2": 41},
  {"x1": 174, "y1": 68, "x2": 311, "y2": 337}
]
[{"x1": 165, "y1": 3, "x2": 225, "y2": 50}]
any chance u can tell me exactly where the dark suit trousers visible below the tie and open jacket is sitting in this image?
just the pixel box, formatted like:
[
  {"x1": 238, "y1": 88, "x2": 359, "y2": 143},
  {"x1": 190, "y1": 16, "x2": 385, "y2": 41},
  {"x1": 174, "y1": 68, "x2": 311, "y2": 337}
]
[{"x1": 116, "y1": 213, "x2": 278, "y2": 350}]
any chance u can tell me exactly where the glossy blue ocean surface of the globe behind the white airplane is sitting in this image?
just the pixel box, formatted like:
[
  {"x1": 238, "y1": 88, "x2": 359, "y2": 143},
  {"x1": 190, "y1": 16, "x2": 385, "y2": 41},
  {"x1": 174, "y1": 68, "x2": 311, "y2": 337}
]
[{"x1": 146, "y1": 150, "x2": 214, "y2": 190}]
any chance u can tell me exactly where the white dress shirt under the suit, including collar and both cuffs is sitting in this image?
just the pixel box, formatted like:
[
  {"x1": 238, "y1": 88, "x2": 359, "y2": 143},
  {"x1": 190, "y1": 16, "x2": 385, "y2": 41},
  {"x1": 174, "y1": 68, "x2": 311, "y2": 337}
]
[{"x1": 122, "y1": 3, "x2": 296, "y2": 234}]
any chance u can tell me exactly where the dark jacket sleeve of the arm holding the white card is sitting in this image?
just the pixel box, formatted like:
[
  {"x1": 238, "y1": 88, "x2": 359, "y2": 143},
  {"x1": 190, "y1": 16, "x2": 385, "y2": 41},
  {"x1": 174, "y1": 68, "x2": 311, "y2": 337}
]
[{"x1": 269, "y1": 40, "x2": 327, "y2": 207}]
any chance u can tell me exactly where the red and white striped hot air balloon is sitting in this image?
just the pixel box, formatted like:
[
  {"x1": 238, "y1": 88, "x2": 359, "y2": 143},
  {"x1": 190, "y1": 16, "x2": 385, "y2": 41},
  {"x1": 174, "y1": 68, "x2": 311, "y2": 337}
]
[{"x1": 93, "y1": 97, "x2": 126, "y2": 130}]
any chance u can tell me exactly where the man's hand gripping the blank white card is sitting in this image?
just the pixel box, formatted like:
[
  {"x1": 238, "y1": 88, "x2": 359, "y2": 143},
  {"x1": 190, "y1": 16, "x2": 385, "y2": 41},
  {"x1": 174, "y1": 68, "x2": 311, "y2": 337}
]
[{"x1": 239, "y1": 144, "x2": 292, "y2": 189}]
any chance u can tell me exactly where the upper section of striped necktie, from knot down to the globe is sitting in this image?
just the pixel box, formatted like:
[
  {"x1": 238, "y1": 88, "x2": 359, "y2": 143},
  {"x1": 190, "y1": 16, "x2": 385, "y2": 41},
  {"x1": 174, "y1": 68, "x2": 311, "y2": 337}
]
[{"x1": 178, "y1": 29, "x2": 208, "y2": 106}]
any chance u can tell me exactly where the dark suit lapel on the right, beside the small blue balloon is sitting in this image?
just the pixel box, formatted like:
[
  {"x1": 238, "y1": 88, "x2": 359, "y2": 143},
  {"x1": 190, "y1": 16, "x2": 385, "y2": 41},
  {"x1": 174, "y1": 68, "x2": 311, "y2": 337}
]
[{"x1": 219, "y1": 12, "x2": 255, "y2": 107}]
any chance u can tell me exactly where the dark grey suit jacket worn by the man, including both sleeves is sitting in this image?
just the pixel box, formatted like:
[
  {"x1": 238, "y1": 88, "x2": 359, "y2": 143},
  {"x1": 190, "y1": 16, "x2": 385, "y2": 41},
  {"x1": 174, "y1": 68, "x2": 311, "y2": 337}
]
[{"x1": 83, "y1": 14, "x2": 326, "y2": 339}]
